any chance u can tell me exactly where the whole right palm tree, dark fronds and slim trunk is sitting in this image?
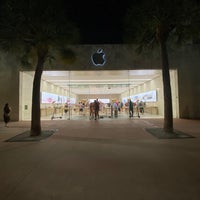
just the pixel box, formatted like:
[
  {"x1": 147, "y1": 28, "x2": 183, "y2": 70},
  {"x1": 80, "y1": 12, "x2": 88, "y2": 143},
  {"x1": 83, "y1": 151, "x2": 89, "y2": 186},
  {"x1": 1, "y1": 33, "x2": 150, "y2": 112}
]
[{"x1": 125, "y1": 0, "x2": 199, "y2": 133}]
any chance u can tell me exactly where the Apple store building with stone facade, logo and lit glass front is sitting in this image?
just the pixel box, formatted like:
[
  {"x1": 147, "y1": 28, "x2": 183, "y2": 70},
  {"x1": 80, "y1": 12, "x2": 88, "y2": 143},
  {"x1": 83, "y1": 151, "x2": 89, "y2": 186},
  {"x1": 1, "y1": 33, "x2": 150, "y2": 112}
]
[{"x1": 1, "y1": 45, "x2": 200, "y2": 120}]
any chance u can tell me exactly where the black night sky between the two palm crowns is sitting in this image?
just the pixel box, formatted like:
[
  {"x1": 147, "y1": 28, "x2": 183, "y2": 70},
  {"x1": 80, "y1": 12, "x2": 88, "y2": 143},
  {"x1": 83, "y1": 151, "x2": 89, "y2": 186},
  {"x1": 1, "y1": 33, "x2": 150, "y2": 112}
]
[{"x1": 66, "y1": 0, "x2": 133, "y2": 44}]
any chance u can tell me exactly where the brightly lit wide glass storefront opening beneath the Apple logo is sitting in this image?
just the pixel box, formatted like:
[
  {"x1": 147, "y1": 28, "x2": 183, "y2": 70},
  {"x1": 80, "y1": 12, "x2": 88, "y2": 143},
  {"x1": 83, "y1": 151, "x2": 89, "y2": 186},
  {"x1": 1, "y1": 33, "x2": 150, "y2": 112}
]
[{"x1": 20, "y1": 70, "x2": 179, "y2": 120}]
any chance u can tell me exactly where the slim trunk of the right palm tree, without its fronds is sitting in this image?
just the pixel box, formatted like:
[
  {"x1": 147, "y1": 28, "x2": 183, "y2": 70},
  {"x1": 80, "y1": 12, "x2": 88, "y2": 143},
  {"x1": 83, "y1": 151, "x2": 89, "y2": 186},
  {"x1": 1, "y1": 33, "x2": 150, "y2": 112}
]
[{"x1": 160, "y1": 40, "x2": 173, "y2": 133}]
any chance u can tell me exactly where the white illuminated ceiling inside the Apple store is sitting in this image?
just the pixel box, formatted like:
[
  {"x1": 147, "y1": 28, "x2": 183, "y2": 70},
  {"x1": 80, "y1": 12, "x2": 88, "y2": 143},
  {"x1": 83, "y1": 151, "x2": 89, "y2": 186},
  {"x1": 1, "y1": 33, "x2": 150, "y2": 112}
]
[{"x1": 38, "y1": 70, "x2": 161, "y2": 94}]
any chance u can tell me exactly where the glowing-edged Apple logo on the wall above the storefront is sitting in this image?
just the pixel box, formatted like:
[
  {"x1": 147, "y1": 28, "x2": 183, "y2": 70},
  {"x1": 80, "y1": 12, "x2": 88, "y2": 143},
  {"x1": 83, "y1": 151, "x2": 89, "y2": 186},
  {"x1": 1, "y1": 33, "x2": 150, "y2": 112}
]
[{"x1": 91, "y1": 49, "x2": 106, "y2": 66}]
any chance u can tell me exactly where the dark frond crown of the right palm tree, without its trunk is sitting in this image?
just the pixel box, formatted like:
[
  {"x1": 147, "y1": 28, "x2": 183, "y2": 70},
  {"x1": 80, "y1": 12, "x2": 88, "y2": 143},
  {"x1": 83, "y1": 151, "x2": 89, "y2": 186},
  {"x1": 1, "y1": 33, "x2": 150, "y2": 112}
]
[{"x1": 124, "y1": 0, "x2": 200, "y2": 52}]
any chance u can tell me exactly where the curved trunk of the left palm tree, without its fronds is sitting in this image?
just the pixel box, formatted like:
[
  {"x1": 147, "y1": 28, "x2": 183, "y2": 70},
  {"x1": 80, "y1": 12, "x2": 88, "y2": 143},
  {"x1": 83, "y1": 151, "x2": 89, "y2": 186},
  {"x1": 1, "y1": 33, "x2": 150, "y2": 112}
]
[{"x1": 30, "y1": 47, "x2": 48, "y2": 136}]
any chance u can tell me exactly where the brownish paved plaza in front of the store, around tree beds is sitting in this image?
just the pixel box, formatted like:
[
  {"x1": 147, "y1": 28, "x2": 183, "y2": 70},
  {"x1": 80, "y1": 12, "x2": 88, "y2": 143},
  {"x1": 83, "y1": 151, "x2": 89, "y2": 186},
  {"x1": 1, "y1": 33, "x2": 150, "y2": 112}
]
[{"x1": 0, "y1": 118, "x2": 200, "y2": 200}]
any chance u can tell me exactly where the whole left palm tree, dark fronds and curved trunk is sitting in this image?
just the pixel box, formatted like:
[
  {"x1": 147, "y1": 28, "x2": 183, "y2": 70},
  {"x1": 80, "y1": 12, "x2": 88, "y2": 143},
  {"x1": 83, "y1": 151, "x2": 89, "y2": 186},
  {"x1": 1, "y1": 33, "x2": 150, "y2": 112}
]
[{"x1": 0, "y1": 0, "x2": 79, "y2": 136}]
